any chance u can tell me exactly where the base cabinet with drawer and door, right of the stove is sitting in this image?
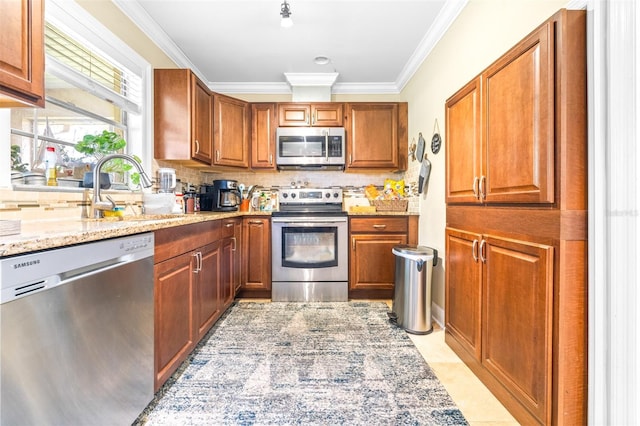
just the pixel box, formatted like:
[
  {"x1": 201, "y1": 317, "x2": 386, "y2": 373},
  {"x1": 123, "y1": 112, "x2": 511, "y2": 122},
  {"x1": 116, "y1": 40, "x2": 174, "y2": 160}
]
[{"x1": 349, "y1": 216, "x2": 418, "y2": 298}]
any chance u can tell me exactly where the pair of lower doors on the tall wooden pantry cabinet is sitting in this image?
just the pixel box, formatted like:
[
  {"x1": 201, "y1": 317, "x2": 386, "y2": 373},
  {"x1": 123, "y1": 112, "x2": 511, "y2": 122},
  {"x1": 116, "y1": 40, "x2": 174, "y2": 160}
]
[{"x1": 445, "y1": 228, "x2": 554, "y2": 423}]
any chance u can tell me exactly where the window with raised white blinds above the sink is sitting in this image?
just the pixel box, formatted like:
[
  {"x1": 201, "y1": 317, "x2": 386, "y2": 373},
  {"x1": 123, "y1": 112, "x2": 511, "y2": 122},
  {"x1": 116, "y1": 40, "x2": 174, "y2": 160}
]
[{"x1": 11, "y1": 23, "x2": 142, "y2": 186}]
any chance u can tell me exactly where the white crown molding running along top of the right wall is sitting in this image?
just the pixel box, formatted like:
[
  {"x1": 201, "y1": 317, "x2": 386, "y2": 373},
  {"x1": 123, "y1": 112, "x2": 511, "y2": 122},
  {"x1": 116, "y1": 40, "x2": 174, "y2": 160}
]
[{"x1": 396, "y1": 0, "x2": 469, "y2": 91}]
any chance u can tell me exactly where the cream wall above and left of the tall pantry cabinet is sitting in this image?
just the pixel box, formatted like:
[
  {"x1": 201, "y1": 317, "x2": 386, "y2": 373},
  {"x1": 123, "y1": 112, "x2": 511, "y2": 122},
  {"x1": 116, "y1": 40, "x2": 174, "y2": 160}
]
[{"x1": 401, "y1": 0, "x2": 568, "y2": 322}]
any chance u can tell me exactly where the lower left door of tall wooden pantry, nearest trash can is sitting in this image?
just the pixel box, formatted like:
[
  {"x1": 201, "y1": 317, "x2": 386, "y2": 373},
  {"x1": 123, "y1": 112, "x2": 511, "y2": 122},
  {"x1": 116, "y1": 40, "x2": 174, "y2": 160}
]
[{"x1": 445, "y1": 228, "x2": 482, "y2": 361}]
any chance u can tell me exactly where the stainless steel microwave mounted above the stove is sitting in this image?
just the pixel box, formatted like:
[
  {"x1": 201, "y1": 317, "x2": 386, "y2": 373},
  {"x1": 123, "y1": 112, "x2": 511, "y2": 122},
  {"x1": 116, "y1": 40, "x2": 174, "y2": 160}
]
[{"x1": 276, "y1": 127, "x2": 346, "y2": 170}]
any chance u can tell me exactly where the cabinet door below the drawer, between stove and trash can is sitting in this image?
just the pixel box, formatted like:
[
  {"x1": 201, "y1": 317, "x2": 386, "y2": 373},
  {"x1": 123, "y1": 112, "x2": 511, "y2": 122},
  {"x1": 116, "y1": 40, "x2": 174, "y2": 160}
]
[{"x1": 349, "y1": 233, "x2": 407, "y2": 296}]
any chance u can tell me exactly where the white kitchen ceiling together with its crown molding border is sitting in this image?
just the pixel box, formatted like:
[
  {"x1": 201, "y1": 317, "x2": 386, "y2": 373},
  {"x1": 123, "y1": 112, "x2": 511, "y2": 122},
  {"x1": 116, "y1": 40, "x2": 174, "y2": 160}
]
[{"x1": 114, "y1": 0, "x2": 467, "y2": 93}]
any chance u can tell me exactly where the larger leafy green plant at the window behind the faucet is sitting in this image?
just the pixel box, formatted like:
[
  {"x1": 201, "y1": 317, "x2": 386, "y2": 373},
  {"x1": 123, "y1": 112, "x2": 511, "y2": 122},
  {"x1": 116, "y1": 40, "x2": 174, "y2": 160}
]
[{"x1": 75, "y1": 130, "x2": 141, "y2": 185}]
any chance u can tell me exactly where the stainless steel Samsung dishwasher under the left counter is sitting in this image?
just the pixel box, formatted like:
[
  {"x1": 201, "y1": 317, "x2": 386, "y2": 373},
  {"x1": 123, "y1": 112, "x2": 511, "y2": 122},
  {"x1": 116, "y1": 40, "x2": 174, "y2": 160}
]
[{"x1": 0, "y1": 233, "x2": 154, "y2": 425}]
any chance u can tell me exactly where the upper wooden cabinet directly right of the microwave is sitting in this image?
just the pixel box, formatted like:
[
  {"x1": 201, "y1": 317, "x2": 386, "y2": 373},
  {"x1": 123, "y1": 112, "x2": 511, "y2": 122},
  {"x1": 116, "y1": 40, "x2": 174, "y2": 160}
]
[{"x1": 345, "y1": 102, "x2": 408, "y2": 171}]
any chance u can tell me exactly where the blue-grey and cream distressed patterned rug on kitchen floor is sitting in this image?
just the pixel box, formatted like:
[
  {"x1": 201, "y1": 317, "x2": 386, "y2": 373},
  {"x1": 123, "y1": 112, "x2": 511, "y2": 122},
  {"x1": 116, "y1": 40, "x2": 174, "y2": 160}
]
[{"x1": 136, "y1": 302, "x2": 467, "y2": 425}]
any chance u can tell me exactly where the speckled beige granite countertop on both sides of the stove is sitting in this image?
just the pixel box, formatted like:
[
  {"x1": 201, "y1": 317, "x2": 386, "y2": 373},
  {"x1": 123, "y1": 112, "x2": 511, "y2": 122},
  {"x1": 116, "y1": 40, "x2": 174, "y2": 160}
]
[{"x1": 0, "y1": 211, "x2": 418, "y2": 257}]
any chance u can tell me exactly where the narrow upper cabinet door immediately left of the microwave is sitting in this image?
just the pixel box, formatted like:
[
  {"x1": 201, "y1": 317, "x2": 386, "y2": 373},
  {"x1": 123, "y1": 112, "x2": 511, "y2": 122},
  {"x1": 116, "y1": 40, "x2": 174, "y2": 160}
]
[{"x1": 251, "y1": 103, "x2": 277, "y2": 170}]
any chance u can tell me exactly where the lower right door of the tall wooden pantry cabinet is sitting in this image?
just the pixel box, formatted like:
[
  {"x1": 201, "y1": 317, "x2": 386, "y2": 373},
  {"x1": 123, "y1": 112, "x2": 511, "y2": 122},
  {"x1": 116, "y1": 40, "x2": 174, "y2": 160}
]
[{"x1": 481, "y1": 236, "x2": 562, "y2": 424}]
